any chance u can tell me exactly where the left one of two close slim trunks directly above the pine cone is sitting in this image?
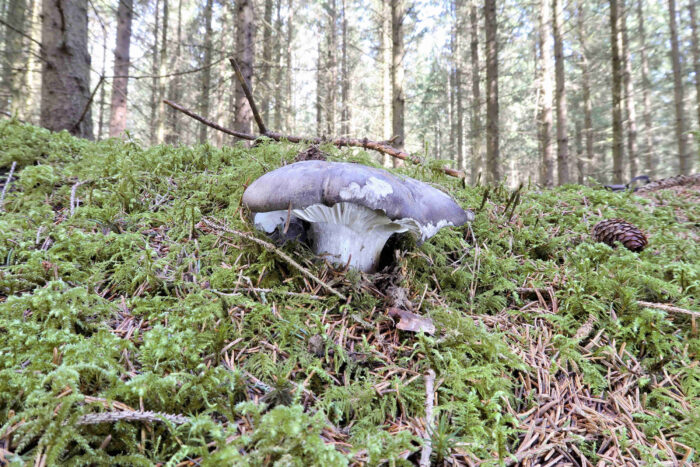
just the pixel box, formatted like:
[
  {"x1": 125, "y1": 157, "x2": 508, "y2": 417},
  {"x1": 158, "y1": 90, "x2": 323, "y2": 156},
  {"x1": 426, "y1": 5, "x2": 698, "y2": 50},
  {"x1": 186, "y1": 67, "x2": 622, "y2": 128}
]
[{"x1": 610, "y1": 0, "x2": 620, "y2": 184}]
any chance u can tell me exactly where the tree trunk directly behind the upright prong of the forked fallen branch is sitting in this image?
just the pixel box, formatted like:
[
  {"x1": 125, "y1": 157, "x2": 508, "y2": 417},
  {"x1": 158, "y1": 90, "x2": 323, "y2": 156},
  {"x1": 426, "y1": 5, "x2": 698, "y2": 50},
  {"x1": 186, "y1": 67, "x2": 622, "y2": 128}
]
[{"x1": 233, "y1": 0, "x2": 255, "y2": 137}]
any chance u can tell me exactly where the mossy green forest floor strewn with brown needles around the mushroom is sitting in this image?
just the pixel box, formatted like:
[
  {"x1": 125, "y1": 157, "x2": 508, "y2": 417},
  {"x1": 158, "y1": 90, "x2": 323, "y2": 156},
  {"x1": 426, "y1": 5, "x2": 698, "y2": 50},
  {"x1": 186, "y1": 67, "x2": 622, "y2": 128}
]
[{"x1": 0, "y1": 120, "x2": 700, "y2": 466}]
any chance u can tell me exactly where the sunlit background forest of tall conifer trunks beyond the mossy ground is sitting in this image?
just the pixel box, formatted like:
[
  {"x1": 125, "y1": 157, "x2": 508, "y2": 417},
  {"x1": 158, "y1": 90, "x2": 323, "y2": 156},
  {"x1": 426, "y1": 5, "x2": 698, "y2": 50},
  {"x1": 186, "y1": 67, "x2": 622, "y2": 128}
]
[{"x1": 0, "y1": 0, "x2": 700, "y2": 186}]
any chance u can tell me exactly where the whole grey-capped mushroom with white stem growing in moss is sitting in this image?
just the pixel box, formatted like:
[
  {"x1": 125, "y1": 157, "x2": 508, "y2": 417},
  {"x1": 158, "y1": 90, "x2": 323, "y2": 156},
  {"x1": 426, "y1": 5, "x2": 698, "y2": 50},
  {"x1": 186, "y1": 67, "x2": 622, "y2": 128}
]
[{"x1": 243, "y1": 161, "x2": 474, "y2": 272}]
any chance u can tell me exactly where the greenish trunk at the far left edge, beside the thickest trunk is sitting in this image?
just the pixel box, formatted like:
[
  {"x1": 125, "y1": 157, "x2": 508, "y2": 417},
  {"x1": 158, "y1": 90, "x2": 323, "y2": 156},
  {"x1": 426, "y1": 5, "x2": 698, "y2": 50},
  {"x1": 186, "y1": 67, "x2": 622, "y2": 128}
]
[{"x1": 0, "y1": 0, "x2": 27, "y2": 114}]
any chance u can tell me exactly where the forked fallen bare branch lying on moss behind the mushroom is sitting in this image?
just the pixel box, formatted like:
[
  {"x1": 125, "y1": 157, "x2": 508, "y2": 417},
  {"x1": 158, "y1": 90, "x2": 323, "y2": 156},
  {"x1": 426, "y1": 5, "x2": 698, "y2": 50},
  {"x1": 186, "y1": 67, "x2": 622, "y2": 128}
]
[{"x1": 163, "y1": 58, "x2": 464, "y2": 178}]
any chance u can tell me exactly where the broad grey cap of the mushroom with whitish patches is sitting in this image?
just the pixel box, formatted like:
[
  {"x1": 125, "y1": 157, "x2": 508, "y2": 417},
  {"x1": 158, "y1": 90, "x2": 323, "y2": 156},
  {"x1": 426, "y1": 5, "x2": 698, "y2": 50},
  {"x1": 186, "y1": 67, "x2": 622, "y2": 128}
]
[{"x1": 243, "y1": 161, "x2": 474, "y2": 234}]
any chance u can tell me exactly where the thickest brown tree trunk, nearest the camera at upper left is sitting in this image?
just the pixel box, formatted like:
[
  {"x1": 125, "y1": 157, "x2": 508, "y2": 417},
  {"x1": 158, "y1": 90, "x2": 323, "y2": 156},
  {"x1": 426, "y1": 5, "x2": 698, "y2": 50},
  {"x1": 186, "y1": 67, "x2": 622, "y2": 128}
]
[{"x1": 41, "y1": 0, "x2": 93, "y2": 139}]
